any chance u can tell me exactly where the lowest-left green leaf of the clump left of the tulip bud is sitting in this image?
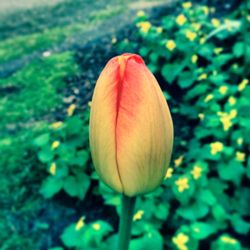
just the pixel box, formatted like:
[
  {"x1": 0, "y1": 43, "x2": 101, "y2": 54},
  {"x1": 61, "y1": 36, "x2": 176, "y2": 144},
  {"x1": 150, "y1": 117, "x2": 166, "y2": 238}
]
[{"x1": 40, "y1": 176, "x2": 63, "y2": 199}]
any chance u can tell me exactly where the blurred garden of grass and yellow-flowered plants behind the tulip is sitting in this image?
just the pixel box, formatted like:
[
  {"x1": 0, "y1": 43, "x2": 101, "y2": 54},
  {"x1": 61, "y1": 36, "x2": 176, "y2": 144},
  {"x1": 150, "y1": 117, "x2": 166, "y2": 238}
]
[{"x1": 0, "y1": 0, "x2": 250, "y2": 250}]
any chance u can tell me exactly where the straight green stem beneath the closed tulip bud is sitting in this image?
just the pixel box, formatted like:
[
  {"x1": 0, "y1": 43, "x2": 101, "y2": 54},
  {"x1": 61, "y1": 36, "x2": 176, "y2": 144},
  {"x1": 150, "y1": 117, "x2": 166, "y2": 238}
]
[{"x1": 118, "y1": 195, "x2": 136, "y2": 250}]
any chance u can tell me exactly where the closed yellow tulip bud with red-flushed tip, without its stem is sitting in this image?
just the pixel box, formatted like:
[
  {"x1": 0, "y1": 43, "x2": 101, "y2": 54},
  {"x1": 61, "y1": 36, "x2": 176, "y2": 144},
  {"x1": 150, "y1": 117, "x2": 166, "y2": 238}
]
[{"x1": 90, "y1": 54, "x2": 173, "y2": 197}]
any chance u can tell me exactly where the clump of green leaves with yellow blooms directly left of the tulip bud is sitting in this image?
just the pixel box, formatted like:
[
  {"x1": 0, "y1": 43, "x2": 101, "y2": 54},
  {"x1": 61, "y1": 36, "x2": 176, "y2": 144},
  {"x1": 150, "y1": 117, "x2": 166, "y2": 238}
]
[{"x1": 34, "y1": 112, "x2": 90, "y2": 200}]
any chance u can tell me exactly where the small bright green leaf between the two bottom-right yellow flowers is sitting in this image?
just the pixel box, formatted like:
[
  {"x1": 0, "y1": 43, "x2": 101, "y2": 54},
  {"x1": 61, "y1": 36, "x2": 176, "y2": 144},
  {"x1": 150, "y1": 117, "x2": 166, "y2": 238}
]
[{"x1": 191, "y1": 222, "x2": 216, "y2": 240}]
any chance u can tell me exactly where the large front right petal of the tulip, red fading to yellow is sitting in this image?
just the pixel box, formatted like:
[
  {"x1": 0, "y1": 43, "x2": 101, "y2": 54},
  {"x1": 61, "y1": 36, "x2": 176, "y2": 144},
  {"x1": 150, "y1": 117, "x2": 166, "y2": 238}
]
[{"x1": 116, "y1": 56, "x2": 173, "y2": 196}]
